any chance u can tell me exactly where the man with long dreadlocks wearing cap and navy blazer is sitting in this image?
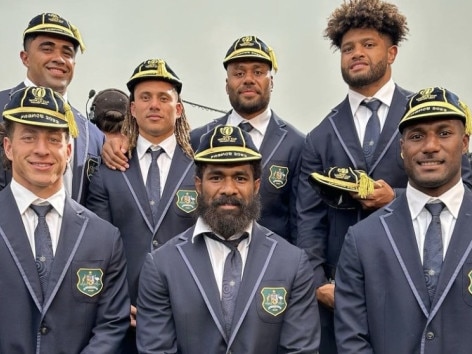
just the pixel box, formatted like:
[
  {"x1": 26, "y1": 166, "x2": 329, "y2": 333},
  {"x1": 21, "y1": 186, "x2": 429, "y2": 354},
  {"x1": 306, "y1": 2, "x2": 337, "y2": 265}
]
[{"x1": 87, "y1": 59, "x2": 197, "y2": 354}]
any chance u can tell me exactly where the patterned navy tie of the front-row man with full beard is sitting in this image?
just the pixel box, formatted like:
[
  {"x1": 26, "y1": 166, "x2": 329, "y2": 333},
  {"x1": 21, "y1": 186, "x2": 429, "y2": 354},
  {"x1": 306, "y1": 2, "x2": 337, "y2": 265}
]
[{"x1": 205, "y1": 232, "x2": 249, "y2": 337}]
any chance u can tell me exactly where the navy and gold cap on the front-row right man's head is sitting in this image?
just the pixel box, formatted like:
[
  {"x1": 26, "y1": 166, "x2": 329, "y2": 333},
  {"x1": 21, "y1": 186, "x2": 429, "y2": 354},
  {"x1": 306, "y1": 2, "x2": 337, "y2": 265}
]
[{"x1": 398, "y1": 87, "x2": 472, "y2": 135}]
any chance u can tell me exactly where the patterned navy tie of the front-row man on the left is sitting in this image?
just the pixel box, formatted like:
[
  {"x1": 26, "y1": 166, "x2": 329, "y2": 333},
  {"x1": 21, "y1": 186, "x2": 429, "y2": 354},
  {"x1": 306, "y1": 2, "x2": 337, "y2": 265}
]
[{"x1": 30, "y1": 204, "x2": 54, "y2": 295}]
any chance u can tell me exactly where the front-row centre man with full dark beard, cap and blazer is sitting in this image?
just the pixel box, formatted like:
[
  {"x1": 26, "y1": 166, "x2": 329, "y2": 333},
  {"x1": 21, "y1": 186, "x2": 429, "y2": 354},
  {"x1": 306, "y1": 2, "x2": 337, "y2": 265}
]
[{"x1": 137, "y1": 125, "x2": 319, "y2": 354}]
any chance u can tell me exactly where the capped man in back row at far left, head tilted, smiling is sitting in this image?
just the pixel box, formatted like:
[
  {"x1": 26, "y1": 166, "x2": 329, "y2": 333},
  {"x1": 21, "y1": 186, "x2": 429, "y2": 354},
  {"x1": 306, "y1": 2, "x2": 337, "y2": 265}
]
[{"x1": 0, "y1": 13, "x2": 104, "y2": 204}]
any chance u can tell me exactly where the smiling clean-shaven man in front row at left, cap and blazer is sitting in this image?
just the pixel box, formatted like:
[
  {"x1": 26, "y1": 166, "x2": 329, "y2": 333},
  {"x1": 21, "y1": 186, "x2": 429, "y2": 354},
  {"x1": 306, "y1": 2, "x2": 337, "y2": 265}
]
[{"x1": 0, "y1": 87, "x2": 129, "y2": 354}]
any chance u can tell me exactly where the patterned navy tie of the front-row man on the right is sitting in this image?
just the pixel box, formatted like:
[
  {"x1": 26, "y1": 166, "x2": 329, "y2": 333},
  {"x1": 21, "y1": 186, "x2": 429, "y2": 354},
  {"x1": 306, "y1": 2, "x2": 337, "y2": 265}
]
[{"x1": 423, "y1": 203, "x2": 445, "y2": 302}]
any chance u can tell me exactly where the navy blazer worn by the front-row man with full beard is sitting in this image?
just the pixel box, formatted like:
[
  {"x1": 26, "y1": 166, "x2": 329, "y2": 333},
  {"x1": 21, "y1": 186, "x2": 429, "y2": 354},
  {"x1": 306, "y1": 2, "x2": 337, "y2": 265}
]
[{"x1": 137, "y1": 223, "x2": 320, "y2": 354}]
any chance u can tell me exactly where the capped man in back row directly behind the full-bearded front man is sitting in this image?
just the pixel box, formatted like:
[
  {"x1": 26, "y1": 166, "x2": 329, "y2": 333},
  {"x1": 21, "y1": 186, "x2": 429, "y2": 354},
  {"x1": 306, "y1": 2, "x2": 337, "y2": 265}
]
[{"x1": 190, "y1": 36, "x2": 305, "y2": 243}]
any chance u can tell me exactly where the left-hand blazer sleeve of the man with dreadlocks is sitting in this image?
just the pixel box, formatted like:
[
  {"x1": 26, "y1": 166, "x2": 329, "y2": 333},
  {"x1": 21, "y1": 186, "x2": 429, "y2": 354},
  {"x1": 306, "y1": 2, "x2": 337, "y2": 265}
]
[{"x1": 85, "y1": 167, "x2": 113, "y2": 223}]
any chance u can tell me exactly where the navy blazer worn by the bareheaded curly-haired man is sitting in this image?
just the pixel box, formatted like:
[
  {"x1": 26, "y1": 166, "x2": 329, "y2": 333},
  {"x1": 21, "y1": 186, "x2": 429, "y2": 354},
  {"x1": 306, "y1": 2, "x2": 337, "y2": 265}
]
[{"x1": 297, "y1": 86, "x2": 472, "y2": 287}]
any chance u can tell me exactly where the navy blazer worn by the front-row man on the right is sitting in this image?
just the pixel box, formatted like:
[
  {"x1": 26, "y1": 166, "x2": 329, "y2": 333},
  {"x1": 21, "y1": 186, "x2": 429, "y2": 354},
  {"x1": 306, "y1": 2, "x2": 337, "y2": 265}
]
[{"x1": 335, "y1": 189, "x2": 472, "y2": 354}]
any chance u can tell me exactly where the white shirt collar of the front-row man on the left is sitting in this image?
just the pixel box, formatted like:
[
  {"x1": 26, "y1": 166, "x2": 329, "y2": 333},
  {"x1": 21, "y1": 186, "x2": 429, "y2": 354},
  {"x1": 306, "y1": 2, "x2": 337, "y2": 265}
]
[{"x1": 10, "y1": 178, "x2": 66, "y2": 216}]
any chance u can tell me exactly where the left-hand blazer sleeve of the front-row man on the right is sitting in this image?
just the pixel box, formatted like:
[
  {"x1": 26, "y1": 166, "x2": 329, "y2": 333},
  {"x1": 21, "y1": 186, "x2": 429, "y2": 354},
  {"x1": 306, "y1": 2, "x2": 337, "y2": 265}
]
[{"x1": 334, "y1": 228, "x2": 374, "y2": 354}]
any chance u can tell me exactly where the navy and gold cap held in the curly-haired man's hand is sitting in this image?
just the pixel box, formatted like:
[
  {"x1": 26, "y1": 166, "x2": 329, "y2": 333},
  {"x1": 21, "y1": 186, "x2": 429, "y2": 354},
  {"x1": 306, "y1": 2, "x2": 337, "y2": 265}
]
[{"x1": 308, "y1": 166, "x2": 375, "y2": 209}]
